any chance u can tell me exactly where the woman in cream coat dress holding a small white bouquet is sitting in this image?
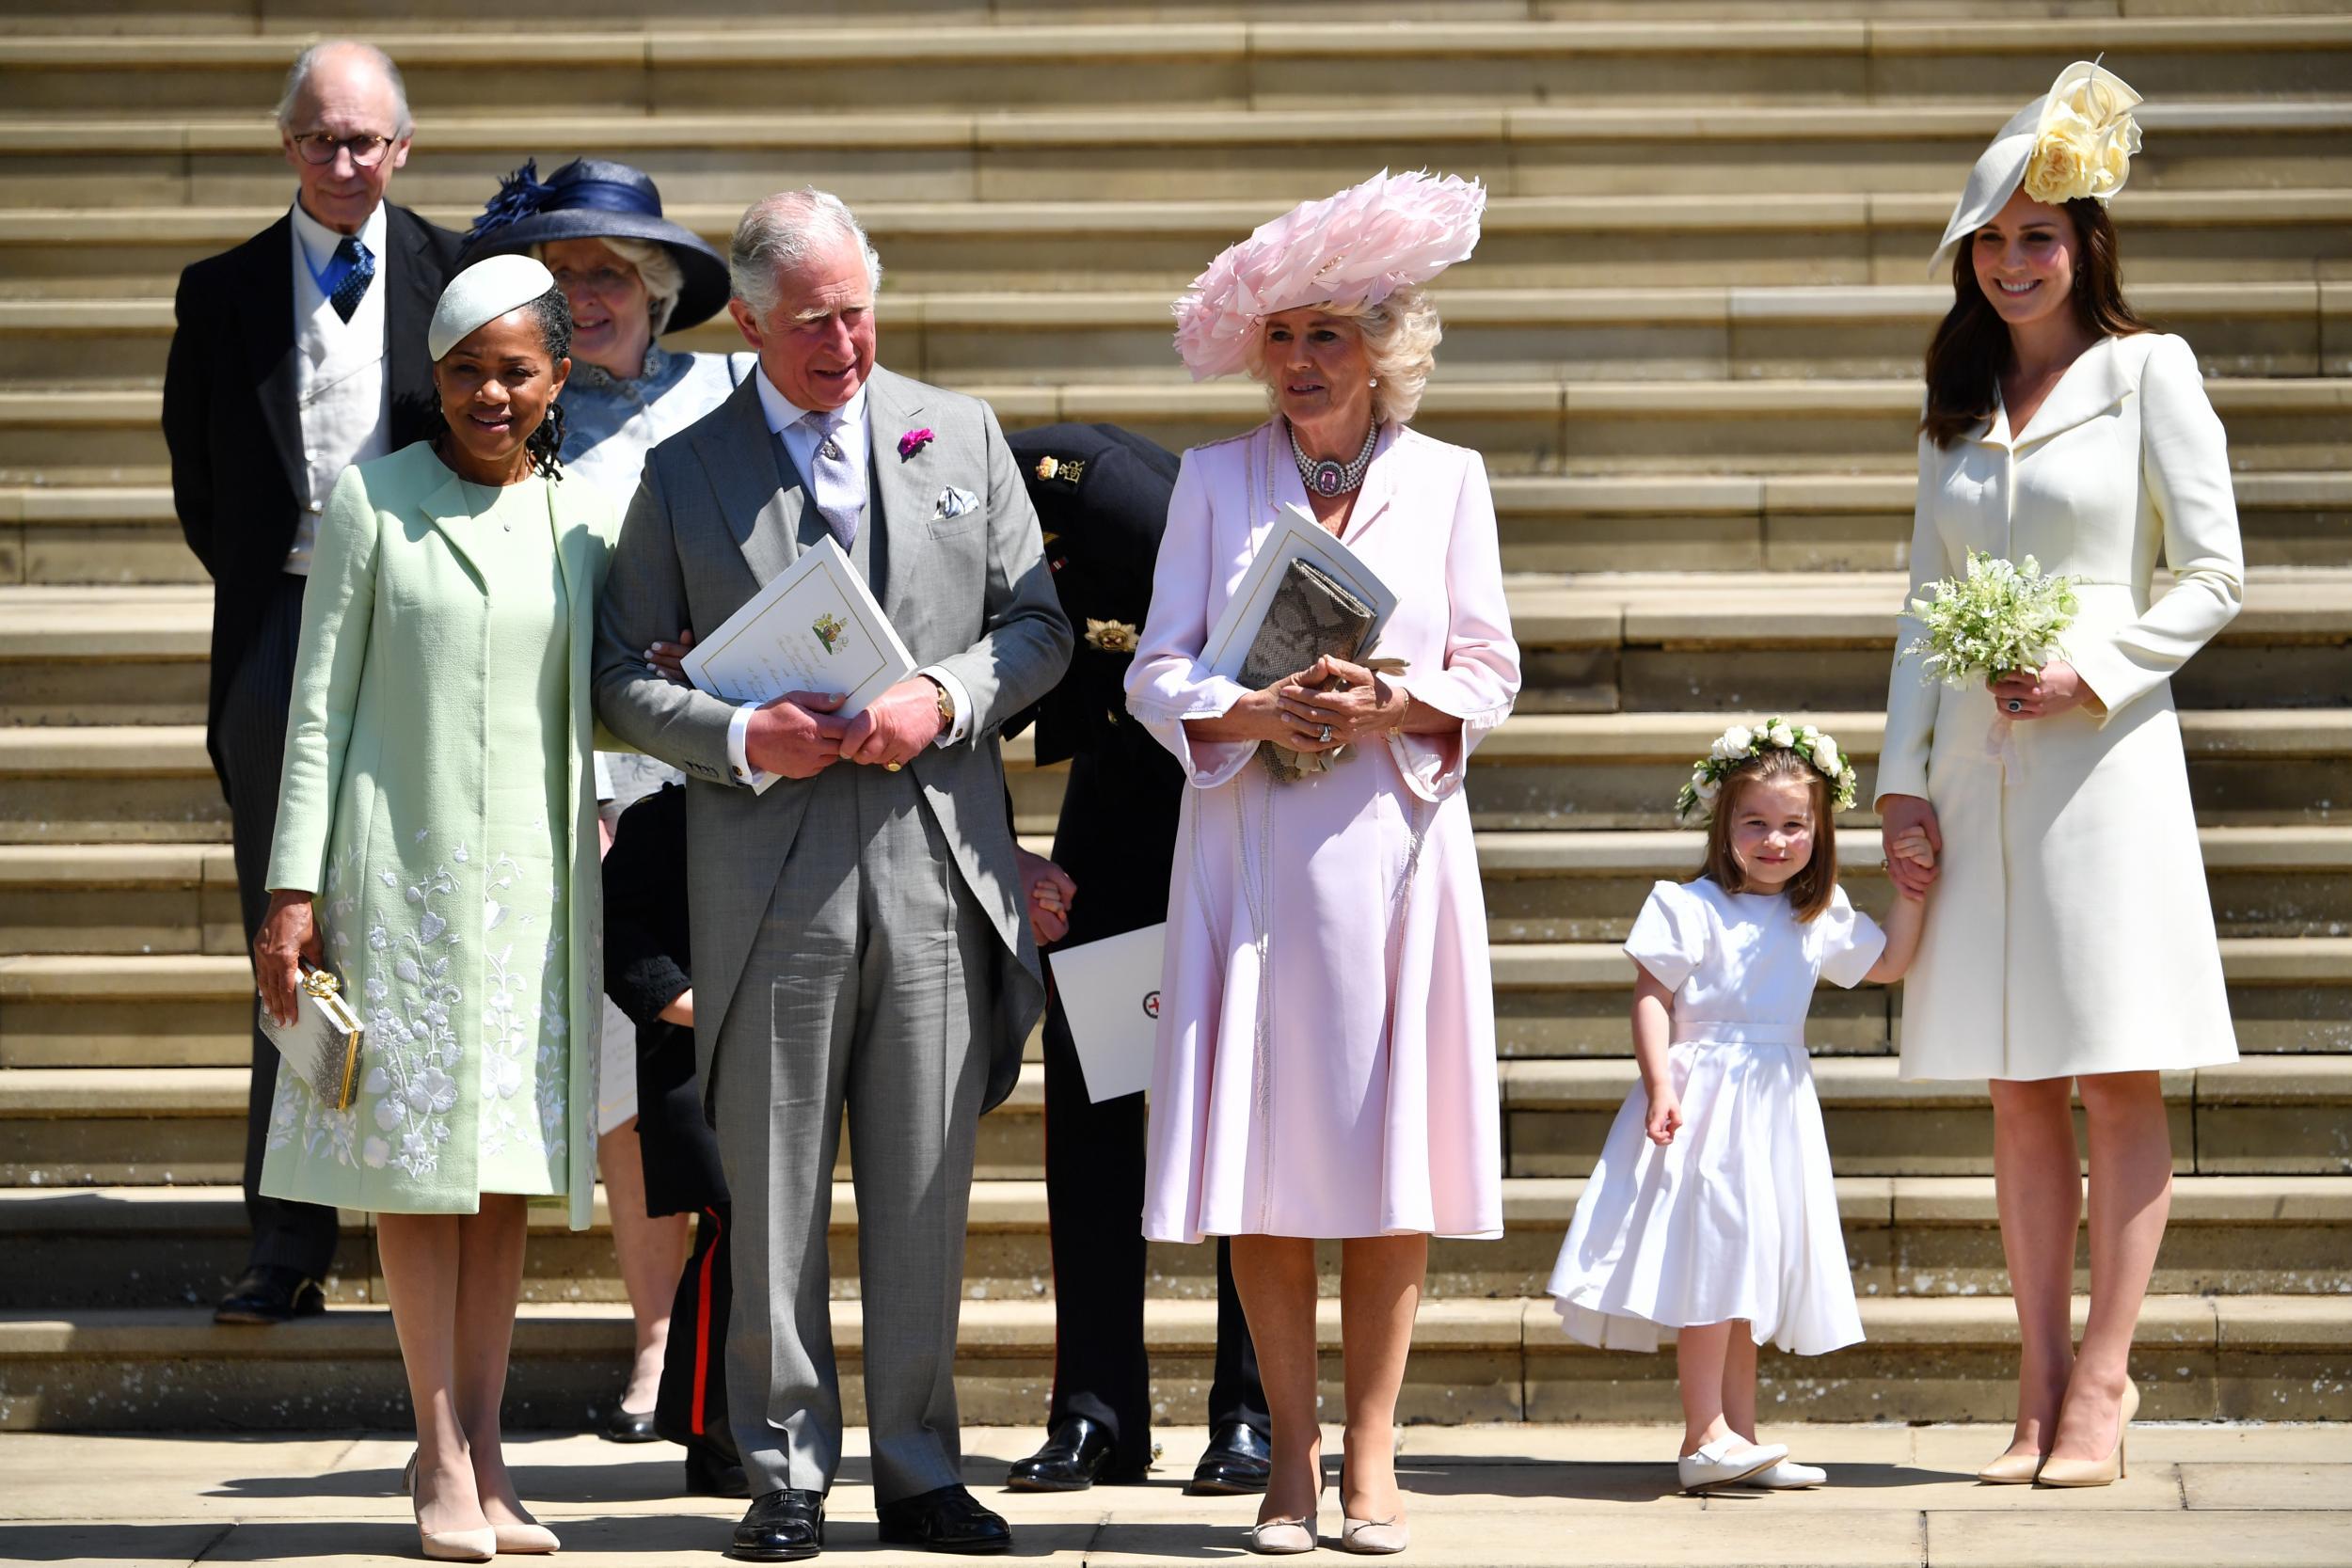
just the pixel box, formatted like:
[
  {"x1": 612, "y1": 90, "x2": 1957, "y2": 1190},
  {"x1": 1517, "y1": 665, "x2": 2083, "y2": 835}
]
[{"x1": 1877, "y1": 66, "x2": 2244, "y2": 1486}]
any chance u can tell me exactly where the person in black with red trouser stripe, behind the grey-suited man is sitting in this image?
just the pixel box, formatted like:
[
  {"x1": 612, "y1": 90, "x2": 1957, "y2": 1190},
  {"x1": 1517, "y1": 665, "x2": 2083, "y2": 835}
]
[{"x1": 605, "y1": 783, "x2": 751, "y2": 1497}]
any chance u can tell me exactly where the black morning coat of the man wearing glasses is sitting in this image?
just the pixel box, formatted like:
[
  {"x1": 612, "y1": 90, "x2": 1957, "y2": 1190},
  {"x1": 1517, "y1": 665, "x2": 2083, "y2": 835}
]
[{"x1": 163, "y1": 207, "x2": 459, "y2": 790}]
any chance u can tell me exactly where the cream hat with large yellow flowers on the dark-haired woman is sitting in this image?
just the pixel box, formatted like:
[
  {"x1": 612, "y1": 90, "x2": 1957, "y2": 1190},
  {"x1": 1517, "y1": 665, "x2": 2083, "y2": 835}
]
[{"x1": 1927, "y1": 58, "x2": 2140, "y2": 277}]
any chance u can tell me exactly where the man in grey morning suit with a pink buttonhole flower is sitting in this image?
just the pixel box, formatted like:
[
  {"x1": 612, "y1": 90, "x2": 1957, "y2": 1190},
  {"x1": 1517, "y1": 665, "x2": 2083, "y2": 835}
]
[{"x1": 596, "y1": 190, "x2": 1071, "y2": 1561}]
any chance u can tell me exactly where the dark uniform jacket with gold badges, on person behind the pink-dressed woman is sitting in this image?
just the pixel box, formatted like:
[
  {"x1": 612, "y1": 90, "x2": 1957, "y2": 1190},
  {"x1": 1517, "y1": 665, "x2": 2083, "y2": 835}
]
[{"x1": 1005, "y1": 425, "x2": 1185, "y2": 947}]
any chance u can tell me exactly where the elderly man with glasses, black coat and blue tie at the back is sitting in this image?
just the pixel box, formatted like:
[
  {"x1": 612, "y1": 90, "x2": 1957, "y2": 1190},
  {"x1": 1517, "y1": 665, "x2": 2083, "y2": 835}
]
[{"x1": 163, "y1": 40, "x2": 459, "y2": 1323}]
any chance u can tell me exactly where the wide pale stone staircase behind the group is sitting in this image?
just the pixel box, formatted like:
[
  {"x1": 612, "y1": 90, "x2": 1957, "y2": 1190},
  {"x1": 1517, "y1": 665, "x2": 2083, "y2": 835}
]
[{"x1": 0, "y1": 0, "x2": 2352, "y2": 1430}]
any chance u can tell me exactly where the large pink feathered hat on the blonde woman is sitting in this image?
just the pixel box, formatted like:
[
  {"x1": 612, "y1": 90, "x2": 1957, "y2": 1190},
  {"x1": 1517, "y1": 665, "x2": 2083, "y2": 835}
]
[{"x1": 1176, "y1": 169, "x2": 1486, "y2": 381}]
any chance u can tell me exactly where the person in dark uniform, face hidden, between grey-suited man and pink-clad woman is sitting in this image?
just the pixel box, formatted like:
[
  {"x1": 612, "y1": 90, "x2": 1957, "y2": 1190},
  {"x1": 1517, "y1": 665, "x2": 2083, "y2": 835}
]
[{"x1": 1005, "y1": 425, "x2": 1268, "y2": 1493}]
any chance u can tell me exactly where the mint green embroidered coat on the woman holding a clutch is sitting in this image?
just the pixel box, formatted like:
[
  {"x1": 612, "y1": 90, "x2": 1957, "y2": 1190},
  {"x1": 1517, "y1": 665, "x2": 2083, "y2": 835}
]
[{"x1": 262, "y1": 442, "x2": 619, "y2": 1229}]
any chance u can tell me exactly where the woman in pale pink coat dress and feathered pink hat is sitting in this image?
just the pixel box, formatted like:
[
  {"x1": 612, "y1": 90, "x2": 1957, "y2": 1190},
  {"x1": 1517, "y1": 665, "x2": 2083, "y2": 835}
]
[{"x1": 1127, "y1": 176, "x2": 1519, "y2": 1552}]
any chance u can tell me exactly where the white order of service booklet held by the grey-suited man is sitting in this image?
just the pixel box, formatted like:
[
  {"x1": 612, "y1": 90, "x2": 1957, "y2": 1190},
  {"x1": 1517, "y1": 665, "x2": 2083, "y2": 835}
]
[{"x1": 680, "y1": 538, "x2": 915, "y2": 792}]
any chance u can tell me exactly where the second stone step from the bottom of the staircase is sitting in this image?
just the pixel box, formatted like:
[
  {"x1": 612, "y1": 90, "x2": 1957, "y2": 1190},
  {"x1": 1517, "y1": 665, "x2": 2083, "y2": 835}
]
[{"x1": 0, "y1": 1176, "x2": 2352, "y2": 1312}]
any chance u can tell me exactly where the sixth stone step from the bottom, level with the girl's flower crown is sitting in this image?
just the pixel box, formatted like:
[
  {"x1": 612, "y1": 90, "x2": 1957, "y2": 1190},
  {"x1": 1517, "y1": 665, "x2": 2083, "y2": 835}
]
[{"x1": 0, "y1": 710, "x2": 2352, "y2": 844}]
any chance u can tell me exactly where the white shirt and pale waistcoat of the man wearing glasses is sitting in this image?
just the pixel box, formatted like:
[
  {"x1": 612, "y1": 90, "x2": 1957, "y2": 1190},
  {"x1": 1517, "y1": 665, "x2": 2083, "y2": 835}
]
[{"x1": 285, "y1": 202, "x2": 393, "y2": 576}]
